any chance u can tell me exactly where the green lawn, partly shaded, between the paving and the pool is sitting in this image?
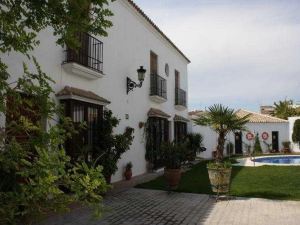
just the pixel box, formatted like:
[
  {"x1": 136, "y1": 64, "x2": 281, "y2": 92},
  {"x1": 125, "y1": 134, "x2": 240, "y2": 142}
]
[{"x1": 136, "y1": 162, "x2": 300, "y2": 200}]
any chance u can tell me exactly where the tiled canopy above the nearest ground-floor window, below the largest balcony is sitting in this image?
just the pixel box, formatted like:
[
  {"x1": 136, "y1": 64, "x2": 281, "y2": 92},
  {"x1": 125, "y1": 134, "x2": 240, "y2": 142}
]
[{"x1": 56, "y1": 86, "x2": 110, "y2": 104}]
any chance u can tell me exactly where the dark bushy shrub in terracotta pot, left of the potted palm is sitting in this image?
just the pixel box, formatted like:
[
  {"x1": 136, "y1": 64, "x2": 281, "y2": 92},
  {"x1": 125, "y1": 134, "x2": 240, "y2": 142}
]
[{"x1": 161, "y1": 142, "x2": 185, "y2": 190}]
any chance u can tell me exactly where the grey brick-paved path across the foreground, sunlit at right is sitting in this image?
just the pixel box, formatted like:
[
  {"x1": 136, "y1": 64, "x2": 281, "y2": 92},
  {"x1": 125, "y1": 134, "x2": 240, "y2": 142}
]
[{"x1": 43, "y1": 188, "x2": 300, "y2": 225}]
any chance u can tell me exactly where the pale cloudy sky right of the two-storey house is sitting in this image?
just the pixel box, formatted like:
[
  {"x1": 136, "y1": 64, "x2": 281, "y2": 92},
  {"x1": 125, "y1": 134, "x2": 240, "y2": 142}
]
[{"x1": 135, "y1": 0, "x2": 300, "y2": 111}]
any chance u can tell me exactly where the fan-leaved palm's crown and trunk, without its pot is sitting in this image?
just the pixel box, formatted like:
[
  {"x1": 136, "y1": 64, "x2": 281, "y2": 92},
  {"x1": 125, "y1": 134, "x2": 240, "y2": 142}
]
[{"x1": 194, "y1": 104, "x2": 250, "y2": 161}]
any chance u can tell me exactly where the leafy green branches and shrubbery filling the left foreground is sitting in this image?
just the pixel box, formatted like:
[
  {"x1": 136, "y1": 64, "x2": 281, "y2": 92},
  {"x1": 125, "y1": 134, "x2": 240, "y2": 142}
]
[{"x1": 0, "y1": 0, "x2": 112, "y2": 225}]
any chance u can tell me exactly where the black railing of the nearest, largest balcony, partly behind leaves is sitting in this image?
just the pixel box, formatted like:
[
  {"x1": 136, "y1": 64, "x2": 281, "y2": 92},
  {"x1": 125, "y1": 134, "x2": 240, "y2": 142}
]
[{"x1": 64, "y1": 33, "x2": 103, "y2": 73}]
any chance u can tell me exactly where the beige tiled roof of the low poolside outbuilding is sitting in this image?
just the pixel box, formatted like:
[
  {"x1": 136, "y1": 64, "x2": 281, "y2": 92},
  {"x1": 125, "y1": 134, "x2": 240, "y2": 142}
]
[{"x1": 236, "y1": 109, "x2": 288, "y2": 123}]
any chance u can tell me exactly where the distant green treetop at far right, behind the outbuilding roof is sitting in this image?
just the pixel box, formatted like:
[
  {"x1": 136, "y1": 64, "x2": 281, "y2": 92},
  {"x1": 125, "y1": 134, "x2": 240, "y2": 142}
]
[{"x1": 273, "y1": 99, "x2": 299, "y2": 120}]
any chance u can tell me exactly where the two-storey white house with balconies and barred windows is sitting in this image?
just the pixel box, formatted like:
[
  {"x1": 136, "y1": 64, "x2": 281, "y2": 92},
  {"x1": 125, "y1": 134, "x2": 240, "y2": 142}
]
[{"x1": 2, "y1": 0, "x2": 190, "y2": 182}]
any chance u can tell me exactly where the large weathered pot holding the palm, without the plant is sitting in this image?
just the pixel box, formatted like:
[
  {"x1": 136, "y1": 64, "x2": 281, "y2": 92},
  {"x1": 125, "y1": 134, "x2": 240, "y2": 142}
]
[{"x1": 207, "y1": 168, "x2": 231, "y2": 193}]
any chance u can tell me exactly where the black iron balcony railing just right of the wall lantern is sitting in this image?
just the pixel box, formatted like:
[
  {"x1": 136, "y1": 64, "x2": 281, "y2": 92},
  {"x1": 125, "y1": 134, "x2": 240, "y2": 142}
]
[{"x1": 150, "y1": 74, "x2": 167, "y2": 99}]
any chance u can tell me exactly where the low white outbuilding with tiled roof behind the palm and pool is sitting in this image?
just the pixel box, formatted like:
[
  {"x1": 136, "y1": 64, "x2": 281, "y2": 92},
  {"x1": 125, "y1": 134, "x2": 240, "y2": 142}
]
[{"x1": 189, "y1": 109, "x2": 290, "y2": 158}]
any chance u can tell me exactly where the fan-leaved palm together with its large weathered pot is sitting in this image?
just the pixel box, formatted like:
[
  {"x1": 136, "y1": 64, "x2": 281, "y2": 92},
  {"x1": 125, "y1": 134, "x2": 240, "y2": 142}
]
[{"x1": 194, "y1": 104, "x2": 249, "y2": 194}]
